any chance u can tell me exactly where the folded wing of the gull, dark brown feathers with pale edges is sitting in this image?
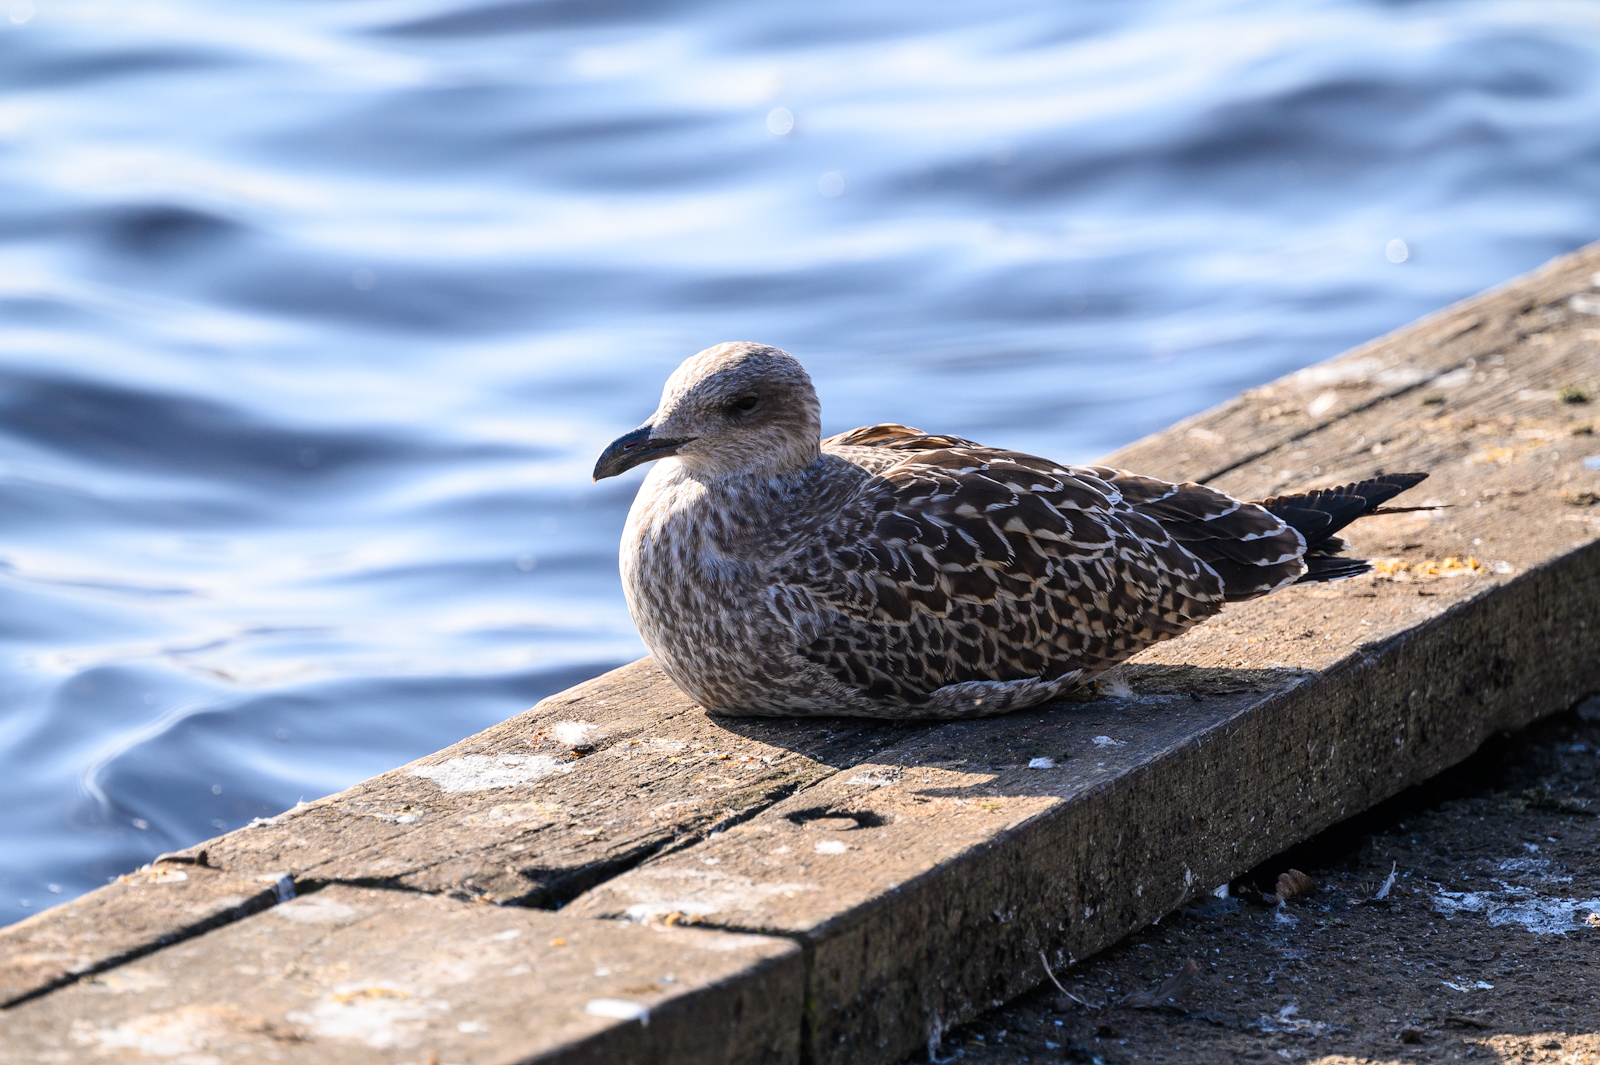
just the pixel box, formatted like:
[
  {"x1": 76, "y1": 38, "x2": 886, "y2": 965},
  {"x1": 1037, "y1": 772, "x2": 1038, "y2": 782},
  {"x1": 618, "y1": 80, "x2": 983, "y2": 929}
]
[{"x1": 781, "y1": 441, "x2": 1222, "y2": 705}]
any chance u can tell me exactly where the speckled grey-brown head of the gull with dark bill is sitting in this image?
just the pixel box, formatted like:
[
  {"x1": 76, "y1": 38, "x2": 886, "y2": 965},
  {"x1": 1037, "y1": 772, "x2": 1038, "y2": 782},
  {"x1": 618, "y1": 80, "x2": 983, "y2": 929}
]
[{"x1": 595, "y1": 341, "x2": 822, "y2": 481}]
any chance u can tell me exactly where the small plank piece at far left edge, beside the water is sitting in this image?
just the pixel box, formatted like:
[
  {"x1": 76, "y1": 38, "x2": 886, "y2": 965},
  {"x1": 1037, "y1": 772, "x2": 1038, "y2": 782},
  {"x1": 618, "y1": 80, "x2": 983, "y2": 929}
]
[{"x1": 0, "y1": 862, "x2": 280, "y2": 1006}]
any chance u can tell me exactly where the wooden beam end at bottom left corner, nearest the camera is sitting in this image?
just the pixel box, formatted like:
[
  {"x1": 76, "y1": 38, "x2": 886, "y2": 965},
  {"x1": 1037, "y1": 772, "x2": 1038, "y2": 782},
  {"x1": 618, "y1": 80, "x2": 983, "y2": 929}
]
[{"x1": 0, "y1": 886, "x2": 805, "y2": 1065}]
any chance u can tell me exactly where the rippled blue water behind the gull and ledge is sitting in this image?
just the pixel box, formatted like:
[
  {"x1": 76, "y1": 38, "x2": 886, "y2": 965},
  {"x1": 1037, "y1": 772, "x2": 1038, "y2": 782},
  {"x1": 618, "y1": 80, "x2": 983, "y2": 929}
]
[{"x1": 0, "y1": 0, "x2": 1600, "y2": 921}]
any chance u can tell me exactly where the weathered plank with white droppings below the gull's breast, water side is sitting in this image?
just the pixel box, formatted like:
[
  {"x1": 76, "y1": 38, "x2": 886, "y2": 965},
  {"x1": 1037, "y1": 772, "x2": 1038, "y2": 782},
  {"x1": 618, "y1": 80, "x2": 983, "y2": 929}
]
[{"x1": 195, "y1": 660, "x2": 928, "y2": 908}]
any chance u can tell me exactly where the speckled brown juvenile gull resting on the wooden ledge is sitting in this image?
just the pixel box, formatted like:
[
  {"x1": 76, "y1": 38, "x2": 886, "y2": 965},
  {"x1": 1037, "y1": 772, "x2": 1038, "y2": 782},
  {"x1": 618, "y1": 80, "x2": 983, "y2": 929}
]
[{"x1": 594, "y1": 342, "x2": 1426, "y2": 718}]
